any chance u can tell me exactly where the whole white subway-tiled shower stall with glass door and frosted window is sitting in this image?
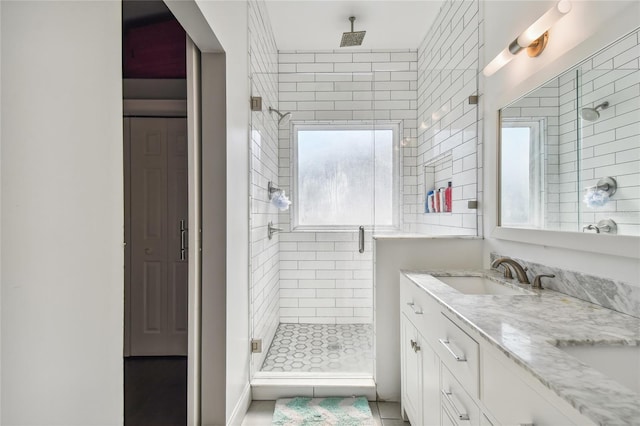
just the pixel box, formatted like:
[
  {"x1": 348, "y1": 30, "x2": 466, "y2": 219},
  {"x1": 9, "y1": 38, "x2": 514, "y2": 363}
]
[{"x1": 249, "y1": 2, "x2": 482, "y2": 396}]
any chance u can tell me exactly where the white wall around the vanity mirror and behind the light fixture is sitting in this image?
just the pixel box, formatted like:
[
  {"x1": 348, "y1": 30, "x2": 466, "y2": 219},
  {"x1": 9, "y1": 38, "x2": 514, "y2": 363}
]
[{"x1": 481, "y1": 1, "x2": 640, "y2": 284}]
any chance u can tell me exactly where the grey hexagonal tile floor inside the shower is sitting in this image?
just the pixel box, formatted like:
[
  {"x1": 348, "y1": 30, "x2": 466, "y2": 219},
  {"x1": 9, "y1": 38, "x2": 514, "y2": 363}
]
[{"x1": 261, "y1": 324, "x2": 373, "y2": 373}]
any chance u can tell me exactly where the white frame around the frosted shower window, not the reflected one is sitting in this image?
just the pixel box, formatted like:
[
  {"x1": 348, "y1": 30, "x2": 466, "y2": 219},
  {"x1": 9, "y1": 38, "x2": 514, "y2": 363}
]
[{"x1": 290, "y1": 121, "x2": 403, "y2": 231}]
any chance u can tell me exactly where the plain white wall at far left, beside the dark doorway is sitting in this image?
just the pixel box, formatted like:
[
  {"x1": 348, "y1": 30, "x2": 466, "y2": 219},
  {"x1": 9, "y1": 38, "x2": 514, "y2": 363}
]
[{"x1": 0, "y1": 1, "x2": 124, "y2": 425}]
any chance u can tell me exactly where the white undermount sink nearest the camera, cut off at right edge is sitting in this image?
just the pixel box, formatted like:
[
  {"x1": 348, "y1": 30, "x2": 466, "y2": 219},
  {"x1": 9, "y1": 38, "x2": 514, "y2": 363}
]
[{"x1": 558, "y1": 345, "x2": 640, "y2": 393}]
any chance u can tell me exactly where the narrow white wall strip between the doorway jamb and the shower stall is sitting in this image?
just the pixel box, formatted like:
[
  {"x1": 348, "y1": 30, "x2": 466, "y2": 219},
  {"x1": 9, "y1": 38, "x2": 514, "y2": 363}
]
[{"x1": 196, "y1": 0, "x2": 251, "y2": 424}]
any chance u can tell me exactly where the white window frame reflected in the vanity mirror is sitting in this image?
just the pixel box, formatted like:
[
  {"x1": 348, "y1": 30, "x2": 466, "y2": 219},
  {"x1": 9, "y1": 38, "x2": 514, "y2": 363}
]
[{"x1": 499, "y1": 117, "x2": 547, "y2": 229}]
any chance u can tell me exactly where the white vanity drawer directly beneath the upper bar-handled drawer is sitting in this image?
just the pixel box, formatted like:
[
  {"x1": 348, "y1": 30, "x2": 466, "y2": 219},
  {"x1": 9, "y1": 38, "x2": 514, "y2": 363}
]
[{"x1": 440, "y1": 363, "x2": 480, "y2": 425}]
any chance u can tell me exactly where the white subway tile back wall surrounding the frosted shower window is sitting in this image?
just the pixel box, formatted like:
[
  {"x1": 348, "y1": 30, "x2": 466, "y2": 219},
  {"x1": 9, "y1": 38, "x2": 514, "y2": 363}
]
[{"x1": 279, "y1": 49, "x2": 417, "y2": 324}]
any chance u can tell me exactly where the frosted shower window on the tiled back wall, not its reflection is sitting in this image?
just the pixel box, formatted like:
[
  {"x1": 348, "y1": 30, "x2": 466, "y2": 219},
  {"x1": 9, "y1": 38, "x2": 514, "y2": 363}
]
[{"x1": 293, "y1": 124, "x2": 399, "y2": 229}]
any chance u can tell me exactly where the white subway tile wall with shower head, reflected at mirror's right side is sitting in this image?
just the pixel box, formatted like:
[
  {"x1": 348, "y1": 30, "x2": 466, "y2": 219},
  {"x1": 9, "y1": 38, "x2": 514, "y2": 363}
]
[{"x1": 579, "y1": 31, "x2": 640, "y2": 236}]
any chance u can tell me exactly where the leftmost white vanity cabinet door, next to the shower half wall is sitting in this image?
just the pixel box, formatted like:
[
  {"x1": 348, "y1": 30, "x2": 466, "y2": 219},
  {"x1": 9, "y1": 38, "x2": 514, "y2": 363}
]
[{"x1": 400, "y1": 315, "x2": 422, "y2": 425}]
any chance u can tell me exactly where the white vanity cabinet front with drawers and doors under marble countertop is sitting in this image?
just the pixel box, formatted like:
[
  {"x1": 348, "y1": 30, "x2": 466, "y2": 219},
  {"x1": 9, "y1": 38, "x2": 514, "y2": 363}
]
[{"x1": 400, "y1": 275, "x2": 592, "y2": 426}]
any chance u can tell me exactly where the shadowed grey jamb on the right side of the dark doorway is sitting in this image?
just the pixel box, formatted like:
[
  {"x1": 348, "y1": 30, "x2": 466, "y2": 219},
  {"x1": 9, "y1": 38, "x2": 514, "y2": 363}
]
[{"x1": 163, "y1": 0, "x2": 230, "y2": 426}]
